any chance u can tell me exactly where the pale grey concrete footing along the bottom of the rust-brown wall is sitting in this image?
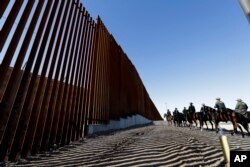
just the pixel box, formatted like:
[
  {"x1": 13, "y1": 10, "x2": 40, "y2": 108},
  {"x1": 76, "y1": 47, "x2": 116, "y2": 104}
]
[{"x1": 88, "y1": 115, "x2": 152, "y2": 135}]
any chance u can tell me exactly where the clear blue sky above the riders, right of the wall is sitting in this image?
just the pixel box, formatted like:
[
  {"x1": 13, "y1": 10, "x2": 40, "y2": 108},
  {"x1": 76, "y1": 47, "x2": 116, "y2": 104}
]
[{"x1": 81, "y1": 0, "x2": 250, "y2": 115}]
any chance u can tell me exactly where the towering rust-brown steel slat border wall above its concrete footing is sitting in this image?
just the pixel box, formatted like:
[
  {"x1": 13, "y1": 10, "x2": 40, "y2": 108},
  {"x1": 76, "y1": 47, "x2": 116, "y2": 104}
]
[{"x1": 0, "y1": 0, "x2": 162, "y2": 161}]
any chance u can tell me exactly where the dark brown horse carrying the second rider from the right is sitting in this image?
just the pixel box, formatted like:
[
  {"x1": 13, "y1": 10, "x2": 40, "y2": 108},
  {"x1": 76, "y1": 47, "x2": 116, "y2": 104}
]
[{"x1": 204, "y1": 106, "x2": 244, "y2": 137}]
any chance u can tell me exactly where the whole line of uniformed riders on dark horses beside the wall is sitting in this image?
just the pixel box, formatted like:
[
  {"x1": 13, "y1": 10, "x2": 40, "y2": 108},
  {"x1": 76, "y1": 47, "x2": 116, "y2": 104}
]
[{"x1": 164, "y1": 98, "x2": 250, "y2": 137}]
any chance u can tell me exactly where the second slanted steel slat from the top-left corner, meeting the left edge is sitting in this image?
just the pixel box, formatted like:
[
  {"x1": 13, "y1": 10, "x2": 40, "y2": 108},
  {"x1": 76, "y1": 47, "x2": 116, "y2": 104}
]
[{"x1": 0, "y1": 0, "x2": 24, "y2": 52}]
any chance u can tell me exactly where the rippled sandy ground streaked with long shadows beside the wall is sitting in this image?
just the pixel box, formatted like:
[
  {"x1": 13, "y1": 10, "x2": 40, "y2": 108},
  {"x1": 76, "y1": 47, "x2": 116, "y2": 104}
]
[{"x1": 3, "y1": 124, "x2": 250, "y2": 167}]
